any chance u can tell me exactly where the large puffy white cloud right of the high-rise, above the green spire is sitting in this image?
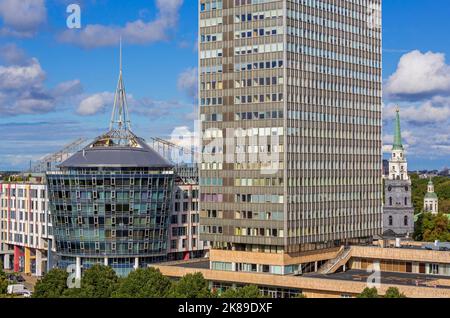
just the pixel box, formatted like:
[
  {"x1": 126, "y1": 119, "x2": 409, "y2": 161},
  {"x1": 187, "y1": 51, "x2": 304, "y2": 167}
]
[{"x1": 385, "y1": 50, "x2": 450, "y2": 98}]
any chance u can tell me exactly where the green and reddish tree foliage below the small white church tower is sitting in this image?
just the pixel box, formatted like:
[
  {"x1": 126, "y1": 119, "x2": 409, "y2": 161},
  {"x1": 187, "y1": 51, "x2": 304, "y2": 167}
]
[{"x1": 414, "y1": 213, "x2": 450, "y2": 242}]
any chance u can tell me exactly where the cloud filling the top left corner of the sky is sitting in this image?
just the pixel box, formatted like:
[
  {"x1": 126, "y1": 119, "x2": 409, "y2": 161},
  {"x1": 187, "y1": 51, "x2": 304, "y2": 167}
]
[{"x1": 0, "y1": 0, "x2": 47, "y2": 37}]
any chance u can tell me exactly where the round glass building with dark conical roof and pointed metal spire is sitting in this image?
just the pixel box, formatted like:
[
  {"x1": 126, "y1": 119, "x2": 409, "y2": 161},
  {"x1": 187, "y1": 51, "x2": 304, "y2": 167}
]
[{"x1": 47, "y1": 46, "x2": 174, "y2": 278}]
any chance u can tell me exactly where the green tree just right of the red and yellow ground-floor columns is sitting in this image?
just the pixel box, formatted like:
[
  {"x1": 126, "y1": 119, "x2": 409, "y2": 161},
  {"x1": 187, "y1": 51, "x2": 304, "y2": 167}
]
[{"x1": 33, "y1": 269, "x2": 69, "y2": 298}]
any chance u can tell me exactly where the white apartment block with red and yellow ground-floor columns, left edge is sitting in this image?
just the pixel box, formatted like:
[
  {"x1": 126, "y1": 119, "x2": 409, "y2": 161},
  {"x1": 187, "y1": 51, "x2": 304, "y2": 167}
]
[{"x1": 0, "y1": 176, "x2": 55, "y2": 276}]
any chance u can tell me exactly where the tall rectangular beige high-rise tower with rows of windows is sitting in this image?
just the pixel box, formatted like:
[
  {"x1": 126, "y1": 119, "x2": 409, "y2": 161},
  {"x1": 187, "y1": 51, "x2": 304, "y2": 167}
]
[{"x1": 199, "y1": 0, "x2": 382, "y2": 274}]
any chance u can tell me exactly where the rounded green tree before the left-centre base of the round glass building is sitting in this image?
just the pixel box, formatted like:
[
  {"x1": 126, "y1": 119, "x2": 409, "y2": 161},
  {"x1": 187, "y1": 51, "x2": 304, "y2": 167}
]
[{"x1": 75, "y1": 265, "x2": 119, "y2": 298}]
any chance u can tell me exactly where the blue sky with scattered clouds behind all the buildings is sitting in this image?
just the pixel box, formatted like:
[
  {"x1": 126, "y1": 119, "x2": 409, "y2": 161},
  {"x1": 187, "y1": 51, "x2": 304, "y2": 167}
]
[{"x1": 0, "y1": 0, "x2": 450, "y2": 170}]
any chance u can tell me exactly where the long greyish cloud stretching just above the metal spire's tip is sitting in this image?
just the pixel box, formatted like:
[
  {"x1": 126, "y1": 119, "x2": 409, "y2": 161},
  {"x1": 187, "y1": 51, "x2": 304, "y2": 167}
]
[{"x1": 59, "y1": 0, "x2": 183, "y2": 48}]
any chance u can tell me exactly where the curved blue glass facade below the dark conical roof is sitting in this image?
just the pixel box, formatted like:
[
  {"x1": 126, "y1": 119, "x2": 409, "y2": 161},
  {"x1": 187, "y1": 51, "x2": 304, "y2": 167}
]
[{"x1": 47, "y1": 167, "x2": 174, "y2": 274}]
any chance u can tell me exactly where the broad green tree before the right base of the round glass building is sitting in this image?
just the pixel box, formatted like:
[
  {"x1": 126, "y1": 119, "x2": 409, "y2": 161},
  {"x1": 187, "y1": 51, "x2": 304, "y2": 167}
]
[{"x1": 113, "y1": 267, "x2": 172, "y2": 298}]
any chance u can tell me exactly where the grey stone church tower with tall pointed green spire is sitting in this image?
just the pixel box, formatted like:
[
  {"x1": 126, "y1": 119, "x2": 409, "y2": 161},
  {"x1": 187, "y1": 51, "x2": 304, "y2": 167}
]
[{"x1": 383, "y1": 109, "x2": 414, "y2": 237}]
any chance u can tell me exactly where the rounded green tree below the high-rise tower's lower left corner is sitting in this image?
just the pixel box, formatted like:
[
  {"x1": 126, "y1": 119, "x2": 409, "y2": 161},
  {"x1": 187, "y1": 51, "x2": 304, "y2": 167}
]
[{"x1": 170, "y1": 273, "x2": 213, "y2": 298}]
